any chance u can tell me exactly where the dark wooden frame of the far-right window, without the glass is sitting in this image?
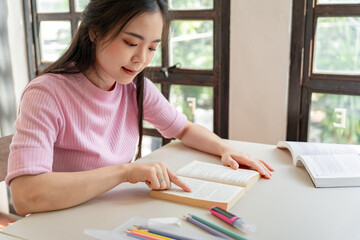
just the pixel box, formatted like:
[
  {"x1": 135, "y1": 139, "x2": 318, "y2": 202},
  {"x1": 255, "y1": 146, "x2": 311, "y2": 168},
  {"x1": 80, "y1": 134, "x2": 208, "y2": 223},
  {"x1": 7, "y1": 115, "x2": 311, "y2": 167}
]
[{"x1": 286, "y1": 0, "x2": 360, "y2": 142}]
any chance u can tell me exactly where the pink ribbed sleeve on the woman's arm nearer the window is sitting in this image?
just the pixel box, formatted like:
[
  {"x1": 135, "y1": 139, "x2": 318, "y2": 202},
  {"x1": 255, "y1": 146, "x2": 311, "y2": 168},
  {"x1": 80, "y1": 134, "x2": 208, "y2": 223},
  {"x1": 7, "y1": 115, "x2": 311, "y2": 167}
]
[{"x1": 144, "y1": 78, "x2": 187, "y2": 138}]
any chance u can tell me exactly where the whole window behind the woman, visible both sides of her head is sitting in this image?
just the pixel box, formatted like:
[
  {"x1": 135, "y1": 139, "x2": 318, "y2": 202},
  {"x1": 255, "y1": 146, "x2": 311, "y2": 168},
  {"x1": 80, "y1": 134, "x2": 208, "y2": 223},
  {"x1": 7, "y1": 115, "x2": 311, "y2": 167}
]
[{"x1": 24, "y1": 0, "x2": 230, "y2": 156}]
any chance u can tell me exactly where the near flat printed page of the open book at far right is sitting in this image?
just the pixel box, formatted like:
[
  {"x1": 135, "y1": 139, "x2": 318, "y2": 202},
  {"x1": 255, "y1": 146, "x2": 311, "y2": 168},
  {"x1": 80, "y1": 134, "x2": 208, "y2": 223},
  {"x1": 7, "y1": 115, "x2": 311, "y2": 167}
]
[{"x1": 299, "y1": 154, "x2": 360, "y2": 178}]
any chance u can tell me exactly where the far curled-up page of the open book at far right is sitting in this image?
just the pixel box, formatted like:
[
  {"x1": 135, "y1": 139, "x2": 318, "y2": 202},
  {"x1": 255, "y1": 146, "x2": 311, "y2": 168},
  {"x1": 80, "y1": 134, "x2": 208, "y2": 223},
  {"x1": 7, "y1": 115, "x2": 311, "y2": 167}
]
[{"x1": 277, "y1": 141, "x2": 360, "y2": 164}]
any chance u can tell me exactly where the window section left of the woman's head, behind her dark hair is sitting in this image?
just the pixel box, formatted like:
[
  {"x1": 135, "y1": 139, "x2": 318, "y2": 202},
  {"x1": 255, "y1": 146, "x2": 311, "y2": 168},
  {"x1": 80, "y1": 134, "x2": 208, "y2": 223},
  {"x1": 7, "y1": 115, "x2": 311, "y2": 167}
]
[{"x1": 23, "y1": 0, "x2": 89, "y2": 79}]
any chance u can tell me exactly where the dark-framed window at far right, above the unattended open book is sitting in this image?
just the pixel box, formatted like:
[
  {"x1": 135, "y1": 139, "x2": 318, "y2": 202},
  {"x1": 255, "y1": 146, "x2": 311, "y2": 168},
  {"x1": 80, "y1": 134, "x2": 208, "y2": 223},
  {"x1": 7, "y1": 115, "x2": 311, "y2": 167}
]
[{"x1": 287, "y1": 0, "x2": 360, "y2": 144}]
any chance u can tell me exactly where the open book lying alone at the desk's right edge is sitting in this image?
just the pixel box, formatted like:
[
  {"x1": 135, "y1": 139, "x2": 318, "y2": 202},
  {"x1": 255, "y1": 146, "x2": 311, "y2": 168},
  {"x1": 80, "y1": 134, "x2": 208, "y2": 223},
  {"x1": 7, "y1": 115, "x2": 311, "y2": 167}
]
[{"x1": 277, "y1": 141, "x2": 360, "y2": 187}]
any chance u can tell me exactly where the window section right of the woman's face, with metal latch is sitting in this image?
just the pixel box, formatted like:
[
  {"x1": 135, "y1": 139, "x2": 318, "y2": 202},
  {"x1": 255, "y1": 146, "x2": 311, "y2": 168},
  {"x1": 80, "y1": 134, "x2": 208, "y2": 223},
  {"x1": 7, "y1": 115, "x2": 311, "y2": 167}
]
[{"x1": 145, "y1": 0, "x2": 230, "y2": 154}]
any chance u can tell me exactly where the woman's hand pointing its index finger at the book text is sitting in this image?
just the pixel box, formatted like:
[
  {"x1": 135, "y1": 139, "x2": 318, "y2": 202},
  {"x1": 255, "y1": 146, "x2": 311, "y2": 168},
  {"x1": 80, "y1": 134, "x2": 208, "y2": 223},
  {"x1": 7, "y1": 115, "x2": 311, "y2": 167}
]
[{"x1": 127, "y1": 162, "x2": 191, "y2": 192}]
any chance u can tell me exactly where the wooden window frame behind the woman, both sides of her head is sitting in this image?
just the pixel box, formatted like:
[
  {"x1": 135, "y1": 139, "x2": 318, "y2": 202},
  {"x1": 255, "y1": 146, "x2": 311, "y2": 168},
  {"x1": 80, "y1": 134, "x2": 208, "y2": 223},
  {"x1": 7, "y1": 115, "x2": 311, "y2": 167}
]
[{"x1": 23, "y1": 0, "x2": 230, "y2": 145}]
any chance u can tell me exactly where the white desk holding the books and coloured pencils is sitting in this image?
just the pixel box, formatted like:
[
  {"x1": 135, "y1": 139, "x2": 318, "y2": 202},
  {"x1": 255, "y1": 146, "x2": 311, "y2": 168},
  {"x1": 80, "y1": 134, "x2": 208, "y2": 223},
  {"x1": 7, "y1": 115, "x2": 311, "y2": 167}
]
[{"x1": 3, "y1": 141, "x2": 360, "y2": 240}]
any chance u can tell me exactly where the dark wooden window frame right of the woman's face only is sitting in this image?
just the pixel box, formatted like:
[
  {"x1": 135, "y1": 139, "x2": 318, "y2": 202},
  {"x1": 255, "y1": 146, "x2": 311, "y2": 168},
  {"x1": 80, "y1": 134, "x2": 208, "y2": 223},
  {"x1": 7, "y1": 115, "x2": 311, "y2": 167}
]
[{"x1": 144, "y1": 0, "x2": 230, "y2": 145}]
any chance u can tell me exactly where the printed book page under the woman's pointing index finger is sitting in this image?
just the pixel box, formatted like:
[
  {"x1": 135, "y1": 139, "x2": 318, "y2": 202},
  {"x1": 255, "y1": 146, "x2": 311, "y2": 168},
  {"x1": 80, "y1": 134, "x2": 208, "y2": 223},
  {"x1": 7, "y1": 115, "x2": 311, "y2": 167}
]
[{"x1": 161, "y1": 176, "x2": 245, "y2": 202}]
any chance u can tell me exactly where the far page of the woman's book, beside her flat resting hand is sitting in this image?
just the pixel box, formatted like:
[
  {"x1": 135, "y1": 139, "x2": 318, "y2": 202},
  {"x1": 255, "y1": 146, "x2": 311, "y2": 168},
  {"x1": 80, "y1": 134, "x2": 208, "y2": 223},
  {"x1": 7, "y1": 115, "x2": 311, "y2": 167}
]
[{"x1": 176, "y1": 160, "x2": 259, "y2": 186}]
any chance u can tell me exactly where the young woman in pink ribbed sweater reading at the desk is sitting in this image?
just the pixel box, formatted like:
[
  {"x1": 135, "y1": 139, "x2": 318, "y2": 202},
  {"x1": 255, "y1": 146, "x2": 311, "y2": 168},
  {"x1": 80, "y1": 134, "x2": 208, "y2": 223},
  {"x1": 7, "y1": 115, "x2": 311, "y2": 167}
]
[{"x1": 6, "y1": 0, "x2": 273, "y2": 215}]
